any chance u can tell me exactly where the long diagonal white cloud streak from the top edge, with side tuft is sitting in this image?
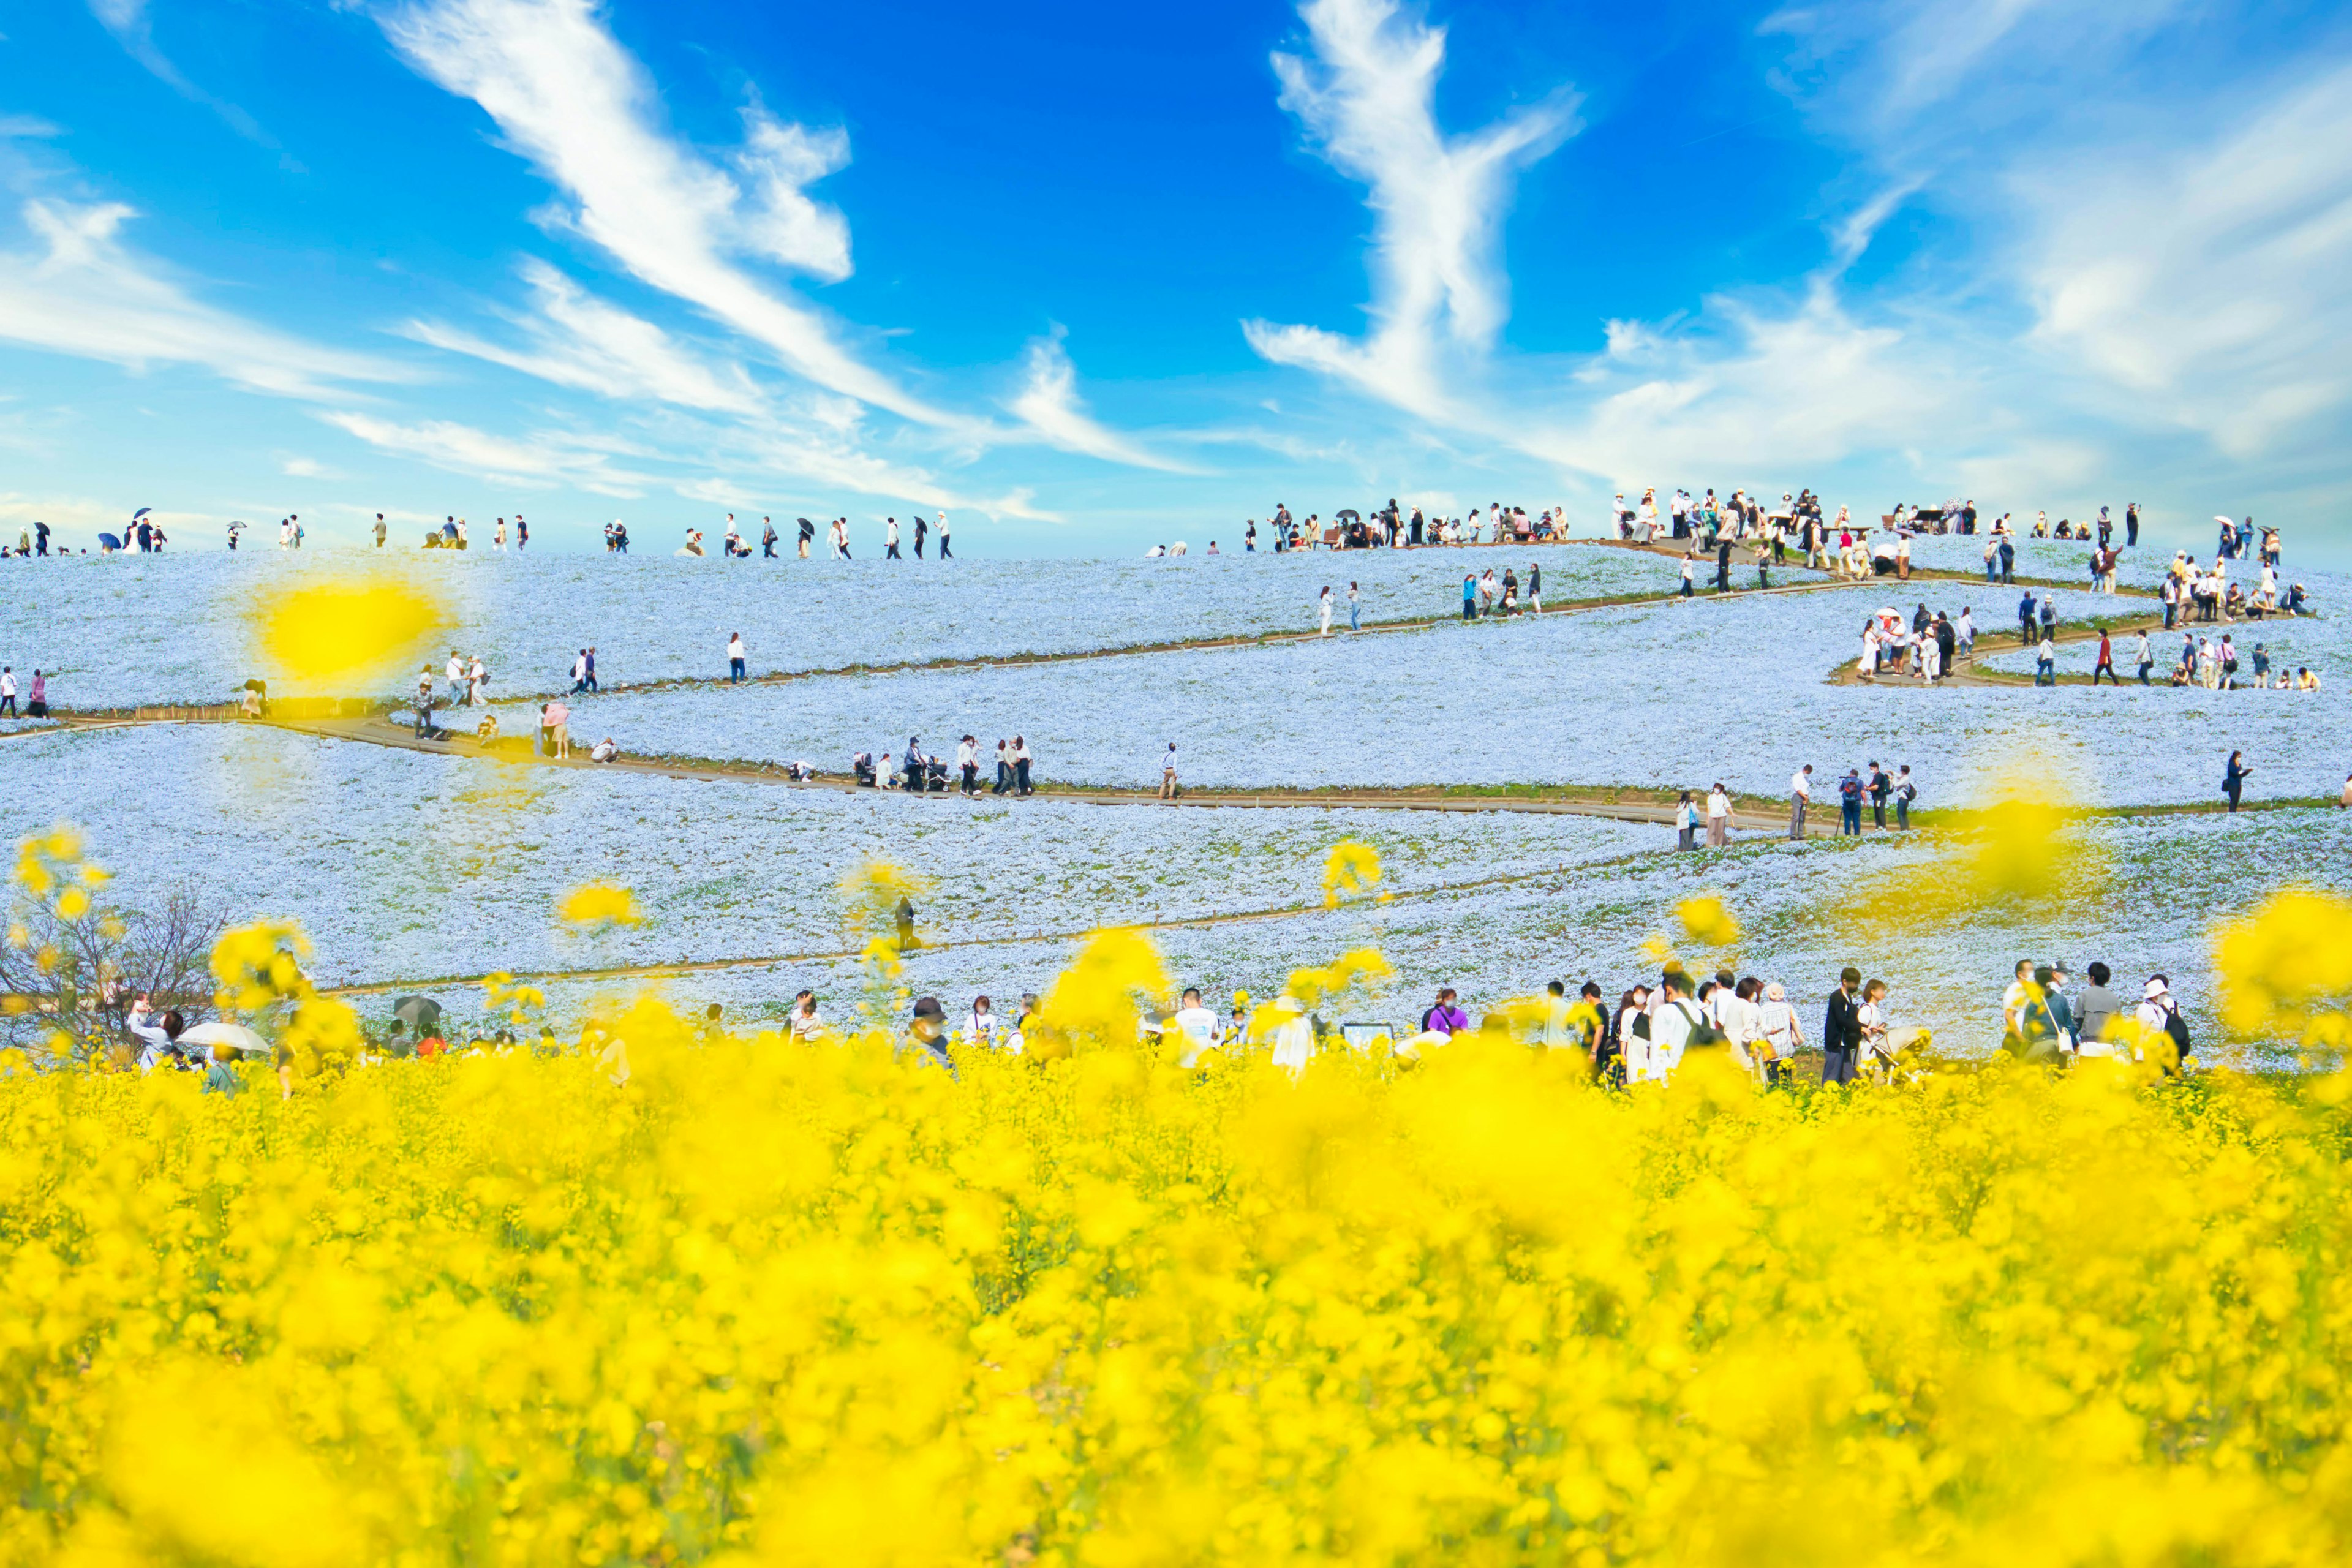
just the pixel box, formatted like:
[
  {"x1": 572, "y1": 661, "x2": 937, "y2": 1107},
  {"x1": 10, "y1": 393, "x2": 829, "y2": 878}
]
[{"x1": 383, "y1": 0, "x2": 957, "y2": 426}]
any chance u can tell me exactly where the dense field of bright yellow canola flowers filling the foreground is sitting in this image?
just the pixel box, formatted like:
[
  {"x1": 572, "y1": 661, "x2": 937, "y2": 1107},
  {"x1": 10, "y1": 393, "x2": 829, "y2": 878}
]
[{"x1": 0, "y1": 1006, "x2": 2352, "y2": 1568}]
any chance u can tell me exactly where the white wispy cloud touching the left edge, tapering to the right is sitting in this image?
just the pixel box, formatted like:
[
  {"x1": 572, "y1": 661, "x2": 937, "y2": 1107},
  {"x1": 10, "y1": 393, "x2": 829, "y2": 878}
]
[{"x1": 0, "y1": 197, "x2": 402, "y2": 399}]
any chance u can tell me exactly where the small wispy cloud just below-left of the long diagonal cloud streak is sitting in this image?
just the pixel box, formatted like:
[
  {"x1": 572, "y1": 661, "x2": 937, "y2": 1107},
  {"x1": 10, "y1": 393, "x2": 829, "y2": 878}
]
[{"x1": 407, "y1": 256, "x2": 760, "y2": 414}]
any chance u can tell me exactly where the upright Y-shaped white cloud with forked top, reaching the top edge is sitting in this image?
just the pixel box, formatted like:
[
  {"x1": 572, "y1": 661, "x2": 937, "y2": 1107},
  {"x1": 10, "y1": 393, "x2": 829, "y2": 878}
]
[{"x1": 1242, "y1": 0, "x2": 1576, "y2": 416}]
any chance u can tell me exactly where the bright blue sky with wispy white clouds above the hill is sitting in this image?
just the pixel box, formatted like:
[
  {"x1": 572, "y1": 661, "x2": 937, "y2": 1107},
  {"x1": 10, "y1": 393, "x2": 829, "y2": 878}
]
[{"x1": 0, "y1": 0, "x2": 2352, "y2": 559}]
